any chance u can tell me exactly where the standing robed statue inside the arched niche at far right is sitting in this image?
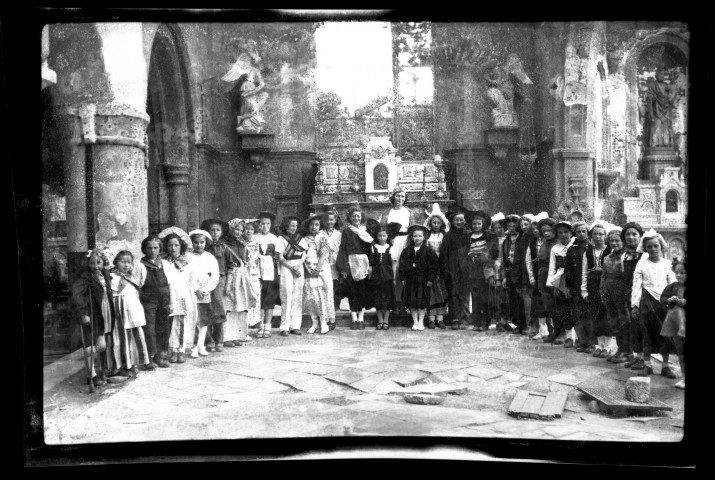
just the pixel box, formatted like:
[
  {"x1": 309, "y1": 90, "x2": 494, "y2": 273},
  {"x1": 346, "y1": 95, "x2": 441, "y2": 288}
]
[{"x1": 643, "y1": 67, "x2": 680, "y2": 147}]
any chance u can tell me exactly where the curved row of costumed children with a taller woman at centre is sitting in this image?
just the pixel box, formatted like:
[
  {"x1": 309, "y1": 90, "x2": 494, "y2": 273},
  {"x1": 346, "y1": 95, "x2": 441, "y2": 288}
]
[{"x1": 73, "y1": 188, "x2": 686, "y2": 388}]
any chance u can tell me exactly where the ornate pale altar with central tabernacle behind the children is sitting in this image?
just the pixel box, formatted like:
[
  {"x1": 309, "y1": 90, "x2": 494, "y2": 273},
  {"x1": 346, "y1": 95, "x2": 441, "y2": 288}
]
[{"x1": 310, "y1": 137, "x2": 454, "y2": 224}]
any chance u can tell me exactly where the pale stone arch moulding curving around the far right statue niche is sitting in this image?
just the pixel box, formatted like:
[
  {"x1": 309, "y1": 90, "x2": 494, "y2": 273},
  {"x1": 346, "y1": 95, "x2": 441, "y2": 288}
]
[{"x1": 619, "y1": 29, "x2": 690, "y2": 186}]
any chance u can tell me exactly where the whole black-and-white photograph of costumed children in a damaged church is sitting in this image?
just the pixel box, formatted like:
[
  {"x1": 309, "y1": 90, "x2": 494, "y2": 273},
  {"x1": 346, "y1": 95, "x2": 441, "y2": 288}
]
[{"x1": 12, "y1": 9, "x2": 707, "y2": 467}]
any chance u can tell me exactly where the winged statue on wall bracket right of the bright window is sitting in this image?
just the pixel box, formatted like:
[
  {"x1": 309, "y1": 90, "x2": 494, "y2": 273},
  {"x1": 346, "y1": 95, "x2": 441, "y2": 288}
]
[{"x1": 486, "y1": 53, "x2": 533, "y2": 128}]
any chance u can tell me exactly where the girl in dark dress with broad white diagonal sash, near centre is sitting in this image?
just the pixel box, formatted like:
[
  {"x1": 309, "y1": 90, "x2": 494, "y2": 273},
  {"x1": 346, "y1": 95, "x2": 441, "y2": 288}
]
[{"x1": 336, "y1": 202, "x2": 374, "y2": 330}]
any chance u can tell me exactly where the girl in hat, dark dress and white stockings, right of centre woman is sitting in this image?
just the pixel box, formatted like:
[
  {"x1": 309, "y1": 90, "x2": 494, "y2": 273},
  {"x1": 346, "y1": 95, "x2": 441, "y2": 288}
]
[{"x1": 399, "y1": 225, "x2": 439, "y2": 330}]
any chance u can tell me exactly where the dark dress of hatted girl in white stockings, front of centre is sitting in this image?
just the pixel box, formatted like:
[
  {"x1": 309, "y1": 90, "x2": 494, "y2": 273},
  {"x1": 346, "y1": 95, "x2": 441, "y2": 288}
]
[{"x1": 399, "y1": 243, "x2": 439, "y2": 308}]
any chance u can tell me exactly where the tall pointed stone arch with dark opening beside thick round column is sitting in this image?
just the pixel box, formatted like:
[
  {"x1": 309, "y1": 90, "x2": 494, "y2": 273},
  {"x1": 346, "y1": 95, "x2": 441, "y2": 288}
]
[{"x1": 147, "y1": 23, "x2": 196, "y2": 231}]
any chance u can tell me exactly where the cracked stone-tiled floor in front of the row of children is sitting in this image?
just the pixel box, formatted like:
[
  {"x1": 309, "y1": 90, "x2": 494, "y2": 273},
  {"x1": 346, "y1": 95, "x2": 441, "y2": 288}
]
[{"x1": 44, "y1": 328, "x2": 684, "y2": 445}]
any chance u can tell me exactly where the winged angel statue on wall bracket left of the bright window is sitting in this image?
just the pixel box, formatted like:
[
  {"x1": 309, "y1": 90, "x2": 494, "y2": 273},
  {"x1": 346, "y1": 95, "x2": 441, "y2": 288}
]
[{"x1": 221, "y1": 53, "x2": 268, "y2": 133}]
